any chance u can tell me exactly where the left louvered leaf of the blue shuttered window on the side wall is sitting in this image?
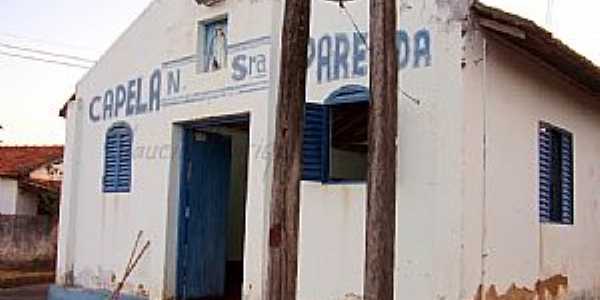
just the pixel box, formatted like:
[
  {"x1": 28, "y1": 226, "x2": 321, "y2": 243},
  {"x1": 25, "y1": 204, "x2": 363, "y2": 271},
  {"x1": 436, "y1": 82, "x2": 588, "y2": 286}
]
[{"x1": 539, "y1": 127, "x2": 552, "y2": 222}]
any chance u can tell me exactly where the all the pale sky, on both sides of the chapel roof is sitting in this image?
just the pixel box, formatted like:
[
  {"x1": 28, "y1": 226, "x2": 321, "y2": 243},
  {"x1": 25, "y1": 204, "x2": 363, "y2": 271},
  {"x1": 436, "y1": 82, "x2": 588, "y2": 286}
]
[{"x1": 0, "y1": 0, "x2": 600, "y2": 145}]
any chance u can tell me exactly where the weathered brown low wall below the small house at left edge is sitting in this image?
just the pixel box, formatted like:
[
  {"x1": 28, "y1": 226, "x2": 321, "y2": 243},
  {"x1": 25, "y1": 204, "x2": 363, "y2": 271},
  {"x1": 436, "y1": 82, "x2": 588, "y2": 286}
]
[{"x1": 0, "y1": 215, "x2": 58, "y2": 270}]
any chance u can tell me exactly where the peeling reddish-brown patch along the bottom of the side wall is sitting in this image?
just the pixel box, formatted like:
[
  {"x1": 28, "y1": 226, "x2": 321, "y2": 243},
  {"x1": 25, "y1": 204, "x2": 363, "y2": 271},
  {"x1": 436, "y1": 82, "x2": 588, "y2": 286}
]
[{"x1": 475, "y1": 274, "x2": 568, "y2": 300}]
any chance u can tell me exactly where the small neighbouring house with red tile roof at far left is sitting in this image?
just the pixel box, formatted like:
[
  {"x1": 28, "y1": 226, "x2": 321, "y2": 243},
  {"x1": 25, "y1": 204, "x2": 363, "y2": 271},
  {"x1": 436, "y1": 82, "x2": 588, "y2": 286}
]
[{"x1": 0, "y1": 146, "x2": 63, "y2": 215}]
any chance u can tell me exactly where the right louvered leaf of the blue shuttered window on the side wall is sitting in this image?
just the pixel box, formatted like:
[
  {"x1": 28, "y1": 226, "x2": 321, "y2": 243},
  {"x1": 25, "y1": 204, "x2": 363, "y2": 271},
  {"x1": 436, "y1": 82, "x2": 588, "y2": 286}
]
[{"x1": 560, "y1": 132, "x2": 573, "y2": 224}]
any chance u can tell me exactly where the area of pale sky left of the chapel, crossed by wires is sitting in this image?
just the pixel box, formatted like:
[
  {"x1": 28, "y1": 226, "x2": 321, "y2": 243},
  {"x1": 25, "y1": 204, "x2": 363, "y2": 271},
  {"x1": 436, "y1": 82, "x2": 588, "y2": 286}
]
[{"x1": 0, "y1": 0, "x2": 152, "y2": 145}]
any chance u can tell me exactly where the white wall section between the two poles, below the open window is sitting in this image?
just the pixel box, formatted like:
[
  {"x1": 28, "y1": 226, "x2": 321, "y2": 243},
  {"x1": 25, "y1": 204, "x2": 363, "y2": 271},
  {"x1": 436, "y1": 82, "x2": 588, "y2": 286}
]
[{"x1": 298, "y1": 182, "x2": 366, "y2": 300}]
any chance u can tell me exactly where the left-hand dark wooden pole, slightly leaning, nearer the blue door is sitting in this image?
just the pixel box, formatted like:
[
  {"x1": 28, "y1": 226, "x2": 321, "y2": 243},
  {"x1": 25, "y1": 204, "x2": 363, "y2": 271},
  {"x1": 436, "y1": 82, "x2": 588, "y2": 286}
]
[{"x1": 268, "y1": 0, "x2": 311, "y2": 300}]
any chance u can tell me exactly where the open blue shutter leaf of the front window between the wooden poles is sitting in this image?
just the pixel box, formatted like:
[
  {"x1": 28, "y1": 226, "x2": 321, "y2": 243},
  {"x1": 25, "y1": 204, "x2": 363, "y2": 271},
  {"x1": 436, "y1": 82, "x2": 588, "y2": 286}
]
[{"x1": 302, "y1": 103, "x2": 329, "y2": 182}]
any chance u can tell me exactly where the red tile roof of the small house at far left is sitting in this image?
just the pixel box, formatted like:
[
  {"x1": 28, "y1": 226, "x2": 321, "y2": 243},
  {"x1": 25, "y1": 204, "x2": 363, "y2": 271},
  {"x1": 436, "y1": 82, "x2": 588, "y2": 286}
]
[{"x1": 0, "y1": 146, "x2": 63, "y2": 178}]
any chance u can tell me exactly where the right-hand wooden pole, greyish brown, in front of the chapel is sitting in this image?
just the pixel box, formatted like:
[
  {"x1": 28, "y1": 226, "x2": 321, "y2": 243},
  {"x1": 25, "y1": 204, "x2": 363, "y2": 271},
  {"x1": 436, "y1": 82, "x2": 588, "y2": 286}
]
[{"x1": 364, "y1": 0, "x2": 398, "y2": 300}]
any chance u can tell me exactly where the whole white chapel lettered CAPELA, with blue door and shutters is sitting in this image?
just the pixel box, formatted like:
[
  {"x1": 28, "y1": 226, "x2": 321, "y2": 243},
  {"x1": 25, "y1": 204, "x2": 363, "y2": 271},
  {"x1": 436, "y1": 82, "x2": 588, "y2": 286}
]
[{"x1": 51, "y1": 0, "x2": 600, "y2": 300}]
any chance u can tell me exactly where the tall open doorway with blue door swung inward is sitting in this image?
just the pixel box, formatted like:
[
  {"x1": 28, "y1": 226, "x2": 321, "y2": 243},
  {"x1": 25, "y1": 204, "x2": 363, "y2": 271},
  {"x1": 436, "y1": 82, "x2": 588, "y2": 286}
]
[{"x1": 177, "y1": 115, "x2": 249, "y2": 300}]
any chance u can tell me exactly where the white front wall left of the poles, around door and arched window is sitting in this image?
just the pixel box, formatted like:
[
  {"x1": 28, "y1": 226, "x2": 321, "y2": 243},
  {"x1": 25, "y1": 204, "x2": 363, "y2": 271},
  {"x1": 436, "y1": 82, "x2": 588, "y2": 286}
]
[{"x1": 57, "y1": 0, "x2": 279, "y2": 299}]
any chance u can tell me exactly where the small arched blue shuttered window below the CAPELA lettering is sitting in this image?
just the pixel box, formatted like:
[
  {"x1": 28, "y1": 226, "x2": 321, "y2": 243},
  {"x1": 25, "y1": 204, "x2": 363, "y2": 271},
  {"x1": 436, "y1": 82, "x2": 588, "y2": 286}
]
[{"x1": 103, "y1": 122, "x2": 133, "y2": 193}]
